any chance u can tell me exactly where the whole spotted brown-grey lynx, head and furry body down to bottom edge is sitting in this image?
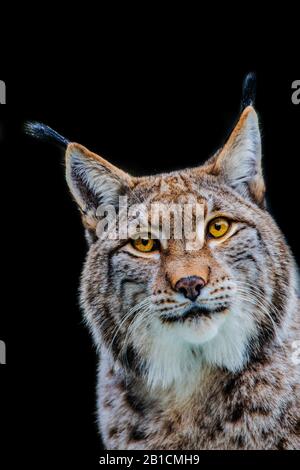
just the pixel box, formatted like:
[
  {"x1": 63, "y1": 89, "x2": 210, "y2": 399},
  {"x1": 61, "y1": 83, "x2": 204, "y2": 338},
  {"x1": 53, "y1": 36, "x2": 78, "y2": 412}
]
[{"x1": 27, "y1": 75, "x2": 300, "y2": 449}]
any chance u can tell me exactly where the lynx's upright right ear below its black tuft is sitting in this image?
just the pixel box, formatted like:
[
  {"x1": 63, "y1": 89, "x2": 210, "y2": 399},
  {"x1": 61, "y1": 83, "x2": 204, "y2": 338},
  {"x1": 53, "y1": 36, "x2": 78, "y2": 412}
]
[{"x1": 212, "y1": 106, "x2": 265, "y2": 204}]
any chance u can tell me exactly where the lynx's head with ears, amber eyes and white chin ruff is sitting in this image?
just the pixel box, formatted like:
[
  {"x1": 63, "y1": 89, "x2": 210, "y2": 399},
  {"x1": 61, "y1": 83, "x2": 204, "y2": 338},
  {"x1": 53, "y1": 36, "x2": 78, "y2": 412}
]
[{"x1": 61, "y1": 106, "x2": 294, "y2": 388}]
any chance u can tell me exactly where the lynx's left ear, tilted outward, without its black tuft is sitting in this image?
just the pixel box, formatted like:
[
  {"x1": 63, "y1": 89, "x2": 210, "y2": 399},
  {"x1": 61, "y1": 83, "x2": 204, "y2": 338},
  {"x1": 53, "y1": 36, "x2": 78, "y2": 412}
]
[{"x1": 66, "y1": 143, "x2": 132, "y2": 230}]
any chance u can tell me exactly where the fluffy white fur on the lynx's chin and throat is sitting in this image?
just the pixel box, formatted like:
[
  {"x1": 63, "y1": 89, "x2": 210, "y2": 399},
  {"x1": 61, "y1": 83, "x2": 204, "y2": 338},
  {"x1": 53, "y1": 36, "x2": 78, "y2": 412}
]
[{"x1": 136, "y1": 309, "x2": 256, "y2": 393}]
